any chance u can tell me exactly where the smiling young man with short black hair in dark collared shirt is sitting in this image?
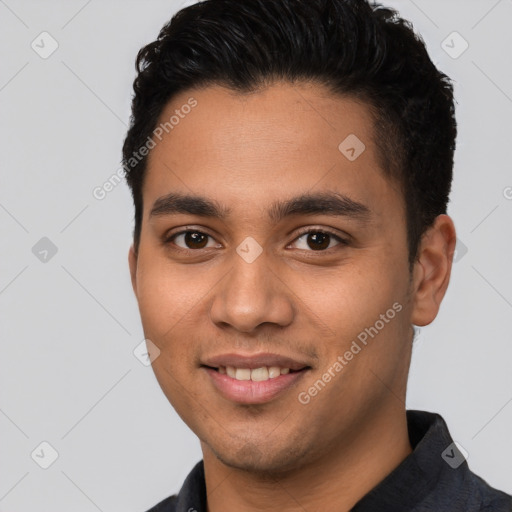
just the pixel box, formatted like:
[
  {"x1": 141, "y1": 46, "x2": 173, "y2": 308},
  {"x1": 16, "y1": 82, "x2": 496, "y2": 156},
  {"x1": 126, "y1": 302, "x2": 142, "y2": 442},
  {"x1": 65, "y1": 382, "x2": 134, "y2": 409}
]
[{"x1": 123, "y1": 0, "x2": 512, "y2": 512}]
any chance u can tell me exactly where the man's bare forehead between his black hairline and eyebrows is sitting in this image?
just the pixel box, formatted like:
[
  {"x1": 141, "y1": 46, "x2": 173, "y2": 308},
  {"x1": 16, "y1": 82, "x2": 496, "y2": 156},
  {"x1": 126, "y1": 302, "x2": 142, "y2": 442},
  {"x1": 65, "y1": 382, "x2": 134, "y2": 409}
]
[{"x1": 144, "y1": 83, "x2": 401, "y2": 222}]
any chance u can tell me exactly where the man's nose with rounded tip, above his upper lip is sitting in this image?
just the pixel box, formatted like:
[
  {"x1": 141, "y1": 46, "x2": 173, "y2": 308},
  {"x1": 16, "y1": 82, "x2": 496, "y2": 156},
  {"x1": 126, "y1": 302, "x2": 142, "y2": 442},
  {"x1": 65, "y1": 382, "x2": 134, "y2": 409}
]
[{"x1": 210, "y1": 252, "x2": 295, "y2": 333}]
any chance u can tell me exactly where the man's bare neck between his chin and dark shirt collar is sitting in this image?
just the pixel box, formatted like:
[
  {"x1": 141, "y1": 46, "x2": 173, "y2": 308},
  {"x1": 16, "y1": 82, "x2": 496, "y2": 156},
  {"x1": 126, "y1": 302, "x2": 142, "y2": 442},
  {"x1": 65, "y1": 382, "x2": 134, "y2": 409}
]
[{"x1": 201, "y1": 403, "x2": 412, "y2": 512}]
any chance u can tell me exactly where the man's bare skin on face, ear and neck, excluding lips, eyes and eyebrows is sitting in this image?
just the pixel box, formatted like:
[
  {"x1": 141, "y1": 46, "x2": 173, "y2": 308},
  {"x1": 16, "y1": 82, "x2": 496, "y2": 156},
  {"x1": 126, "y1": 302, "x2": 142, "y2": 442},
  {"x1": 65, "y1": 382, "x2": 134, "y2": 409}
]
[{"x1": 129, "y1": 83, "x2": 455, "y2": 512}]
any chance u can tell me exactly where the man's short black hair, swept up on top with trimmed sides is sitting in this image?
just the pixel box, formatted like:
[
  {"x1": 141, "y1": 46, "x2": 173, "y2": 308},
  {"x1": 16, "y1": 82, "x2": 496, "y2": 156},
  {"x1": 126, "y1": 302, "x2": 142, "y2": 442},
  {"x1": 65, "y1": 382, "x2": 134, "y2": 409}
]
[{"x1": 123, "y1": 0, "x2": 457, "y2": 269}]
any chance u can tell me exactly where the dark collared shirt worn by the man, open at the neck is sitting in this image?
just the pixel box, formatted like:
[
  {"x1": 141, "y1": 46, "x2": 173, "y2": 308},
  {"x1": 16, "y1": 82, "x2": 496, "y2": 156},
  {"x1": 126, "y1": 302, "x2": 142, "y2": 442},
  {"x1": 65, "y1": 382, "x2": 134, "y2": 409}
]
[{"x1": 148, "y1": 410, "x2": 512, "y2": 512}]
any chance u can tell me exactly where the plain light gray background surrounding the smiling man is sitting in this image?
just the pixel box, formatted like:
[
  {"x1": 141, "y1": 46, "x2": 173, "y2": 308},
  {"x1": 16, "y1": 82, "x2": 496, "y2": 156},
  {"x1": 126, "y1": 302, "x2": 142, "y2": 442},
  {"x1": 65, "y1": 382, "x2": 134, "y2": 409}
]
[{"x1": 0, "y1": 0, "x2": 512, "y2": 512}]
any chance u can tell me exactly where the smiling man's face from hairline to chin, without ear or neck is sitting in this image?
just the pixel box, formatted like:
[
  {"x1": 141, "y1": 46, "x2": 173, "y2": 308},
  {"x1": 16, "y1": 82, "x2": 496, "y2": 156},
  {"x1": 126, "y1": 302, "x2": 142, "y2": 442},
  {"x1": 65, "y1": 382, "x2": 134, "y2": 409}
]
[{"x1": 130, "y1": 84, "x2": 413, "y2": 472}]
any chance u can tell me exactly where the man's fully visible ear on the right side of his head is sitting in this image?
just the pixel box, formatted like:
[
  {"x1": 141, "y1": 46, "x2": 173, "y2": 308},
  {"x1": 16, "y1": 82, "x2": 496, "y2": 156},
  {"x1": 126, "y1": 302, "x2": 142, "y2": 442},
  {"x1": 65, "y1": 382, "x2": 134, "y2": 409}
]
[{"x1": 411, "y1": 214, "x2": 456, "y2": 326}]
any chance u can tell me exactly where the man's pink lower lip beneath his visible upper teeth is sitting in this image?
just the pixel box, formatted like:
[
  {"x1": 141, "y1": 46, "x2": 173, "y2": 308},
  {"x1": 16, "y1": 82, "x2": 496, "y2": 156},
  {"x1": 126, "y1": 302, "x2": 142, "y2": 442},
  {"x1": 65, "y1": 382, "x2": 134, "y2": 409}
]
[{"x1": 202, "y1": 366, "x2": 307, "y2": 404}]
